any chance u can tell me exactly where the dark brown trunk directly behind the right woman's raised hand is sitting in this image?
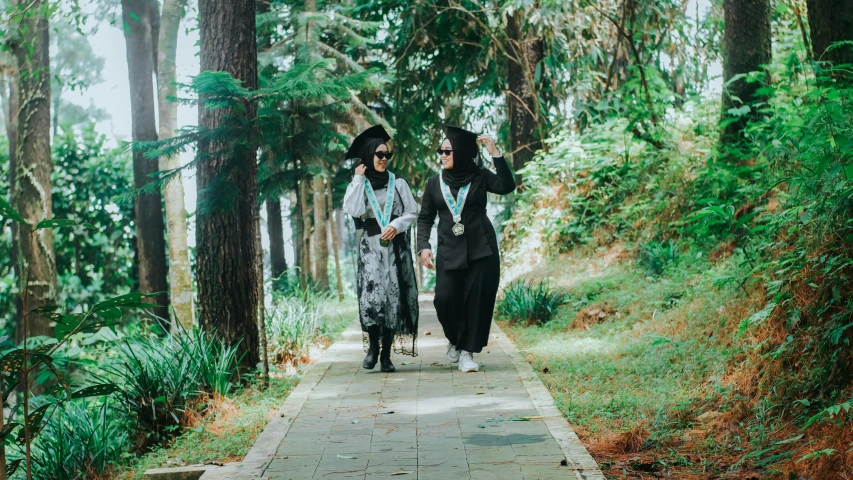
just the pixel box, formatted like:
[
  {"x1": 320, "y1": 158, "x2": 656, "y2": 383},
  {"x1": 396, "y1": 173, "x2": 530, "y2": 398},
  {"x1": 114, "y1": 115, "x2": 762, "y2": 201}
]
[{"x1": 507, "y1": 6, "x2": 544, "y2": 181}]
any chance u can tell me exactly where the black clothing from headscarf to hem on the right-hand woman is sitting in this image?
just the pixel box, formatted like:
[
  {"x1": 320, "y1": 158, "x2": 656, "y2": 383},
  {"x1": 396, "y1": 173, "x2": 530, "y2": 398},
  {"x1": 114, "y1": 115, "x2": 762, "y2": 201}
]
[{"x1": 418, "y1": 156, "x2": 515, "y2": 353}]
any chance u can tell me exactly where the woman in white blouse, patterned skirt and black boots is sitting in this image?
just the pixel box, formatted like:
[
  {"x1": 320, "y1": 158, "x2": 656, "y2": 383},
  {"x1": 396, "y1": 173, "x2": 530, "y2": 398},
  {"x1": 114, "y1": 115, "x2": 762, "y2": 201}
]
[{"x1": 344, "y1": 125, "x2": 418, "y2": 372}]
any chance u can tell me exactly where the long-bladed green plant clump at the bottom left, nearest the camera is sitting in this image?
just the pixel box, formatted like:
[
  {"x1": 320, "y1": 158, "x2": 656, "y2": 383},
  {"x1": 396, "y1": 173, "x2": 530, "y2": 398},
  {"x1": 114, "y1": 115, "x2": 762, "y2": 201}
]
[{"x1": 26, "y1": 401, "x2": 128, "y2": 480}]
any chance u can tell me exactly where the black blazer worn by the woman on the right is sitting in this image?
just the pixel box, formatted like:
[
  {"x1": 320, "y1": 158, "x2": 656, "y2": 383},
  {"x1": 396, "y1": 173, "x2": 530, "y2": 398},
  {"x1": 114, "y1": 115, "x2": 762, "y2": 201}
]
[{"x1": 418, "y1": 156, "x2": 515, "y2": 270}]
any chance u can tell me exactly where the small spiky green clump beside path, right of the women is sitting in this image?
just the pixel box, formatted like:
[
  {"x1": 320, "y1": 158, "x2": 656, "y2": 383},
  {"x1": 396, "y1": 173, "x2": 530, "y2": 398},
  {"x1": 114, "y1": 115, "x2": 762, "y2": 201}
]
[{"x1": 497, "y1": 280, "x2": 566, "y2": 325}]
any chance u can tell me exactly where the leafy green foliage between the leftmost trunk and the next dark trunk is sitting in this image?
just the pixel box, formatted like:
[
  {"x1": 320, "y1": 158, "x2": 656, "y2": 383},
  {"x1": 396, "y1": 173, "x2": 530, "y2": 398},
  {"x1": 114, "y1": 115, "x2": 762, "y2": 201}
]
[{"x1": 51, "y1": 123, "x2": 138, "y2": 305}]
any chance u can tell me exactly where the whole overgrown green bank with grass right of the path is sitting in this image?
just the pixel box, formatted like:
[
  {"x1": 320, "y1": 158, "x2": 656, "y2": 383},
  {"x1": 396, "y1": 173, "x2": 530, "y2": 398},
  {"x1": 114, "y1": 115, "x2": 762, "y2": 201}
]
[{"x1": 499, "y1": 65, "x2": 853, "y2": 479}]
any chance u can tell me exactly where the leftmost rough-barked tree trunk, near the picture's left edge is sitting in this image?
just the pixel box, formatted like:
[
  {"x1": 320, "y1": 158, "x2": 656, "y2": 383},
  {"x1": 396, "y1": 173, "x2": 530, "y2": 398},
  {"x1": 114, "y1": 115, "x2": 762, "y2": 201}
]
[{"x1": 12, "y1": 0, "x2": 57, "y2": 340}]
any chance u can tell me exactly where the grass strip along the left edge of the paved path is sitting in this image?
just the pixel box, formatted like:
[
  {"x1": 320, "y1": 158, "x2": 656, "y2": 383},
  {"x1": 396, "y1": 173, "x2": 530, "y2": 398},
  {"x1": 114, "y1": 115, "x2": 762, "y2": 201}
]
[{"x1": 112, "y1": 300, "x2": 357, "y2": 480}]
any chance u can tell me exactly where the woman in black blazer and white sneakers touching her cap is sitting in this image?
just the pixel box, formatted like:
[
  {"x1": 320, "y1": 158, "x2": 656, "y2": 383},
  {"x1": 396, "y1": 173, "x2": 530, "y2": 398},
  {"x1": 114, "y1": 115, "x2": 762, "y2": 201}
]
[{"x1": 418, "y1": 126, "x2": 515, "y2": 372}]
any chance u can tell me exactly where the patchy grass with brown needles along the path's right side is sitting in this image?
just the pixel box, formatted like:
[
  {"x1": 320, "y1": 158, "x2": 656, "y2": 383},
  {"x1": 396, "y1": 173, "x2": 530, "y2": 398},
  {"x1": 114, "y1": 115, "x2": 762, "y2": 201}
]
[{"x1": 501, "y1": 249, "x2": 756, "y2": 479}]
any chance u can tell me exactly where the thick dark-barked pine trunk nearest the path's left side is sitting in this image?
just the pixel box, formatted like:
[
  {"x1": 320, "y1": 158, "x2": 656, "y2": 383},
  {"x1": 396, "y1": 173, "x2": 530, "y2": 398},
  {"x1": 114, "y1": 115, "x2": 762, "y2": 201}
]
[{"x1": 196, "y1": 0, "x2": 263, "y2": 370}]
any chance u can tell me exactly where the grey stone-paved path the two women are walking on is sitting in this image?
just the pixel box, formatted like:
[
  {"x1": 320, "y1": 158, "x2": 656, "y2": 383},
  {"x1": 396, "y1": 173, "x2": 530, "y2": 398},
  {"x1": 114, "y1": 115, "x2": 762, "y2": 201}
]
[{"x1": 202, "y1": 303, "x2": 604, "y2": 480}]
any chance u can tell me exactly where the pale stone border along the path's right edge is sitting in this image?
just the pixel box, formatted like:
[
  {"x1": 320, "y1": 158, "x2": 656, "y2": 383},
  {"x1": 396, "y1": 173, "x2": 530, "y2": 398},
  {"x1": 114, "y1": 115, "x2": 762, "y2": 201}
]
[{"x1": 492, "y1": 322, "x2": 605, "y2": 480}]
